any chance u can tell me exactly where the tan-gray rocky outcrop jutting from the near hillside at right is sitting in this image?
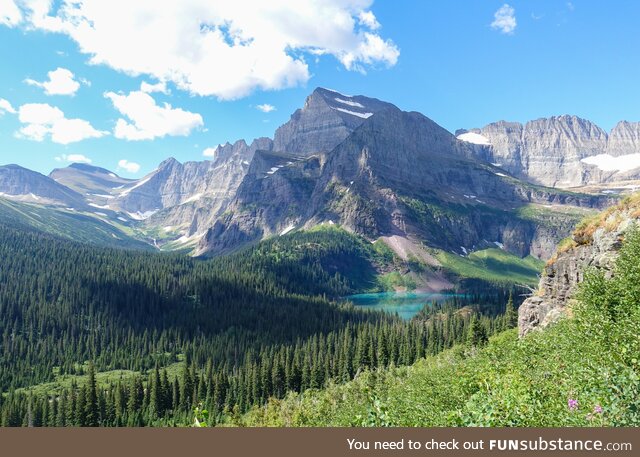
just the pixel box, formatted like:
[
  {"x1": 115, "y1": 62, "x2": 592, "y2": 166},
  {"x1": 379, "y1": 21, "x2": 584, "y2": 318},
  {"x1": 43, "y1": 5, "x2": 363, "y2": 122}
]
[{"x1": 518, "y1": 211, "x2": 636, "y2": 336}]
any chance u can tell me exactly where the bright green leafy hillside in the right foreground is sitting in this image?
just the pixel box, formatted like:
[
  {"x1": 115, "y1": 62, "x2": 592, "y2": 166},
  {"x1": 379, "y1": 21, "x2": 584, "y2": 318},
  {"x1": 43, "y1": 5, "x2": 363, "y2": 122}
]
[{"x1": 240, "y1": 232, "x2": 640, "y2": 427}]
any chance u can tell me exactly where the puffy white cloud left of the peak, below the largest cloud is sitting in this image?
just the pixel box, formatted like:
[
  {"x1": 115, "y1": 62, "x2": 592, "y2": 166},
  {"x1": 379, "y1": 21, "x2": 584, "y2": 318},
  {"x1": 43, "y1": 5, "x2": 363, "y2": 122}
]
[{"x1": 104, "y1": 91, "x2": 203, "y2": 141}]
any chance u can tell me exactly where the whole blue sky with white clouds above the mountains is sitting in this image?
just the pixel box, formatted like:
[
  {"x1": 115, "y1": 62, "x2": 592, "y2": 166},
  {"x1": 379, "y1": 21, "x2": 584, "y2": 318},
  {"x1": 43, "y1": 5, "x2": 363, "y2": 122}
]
[{"x1": 0, "y1": 0, "x2": 640, "y2": 177}]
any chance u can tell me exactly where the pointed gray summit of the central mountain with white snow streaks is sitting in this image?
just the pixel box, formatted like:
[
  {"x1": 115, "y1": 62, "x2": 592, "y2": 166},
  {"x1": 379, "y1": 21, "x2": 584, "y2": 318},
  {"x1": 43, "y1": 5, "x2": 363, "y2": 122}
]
[{"x1": 273, "y1": 88, "x2": 394, "y2": 156}]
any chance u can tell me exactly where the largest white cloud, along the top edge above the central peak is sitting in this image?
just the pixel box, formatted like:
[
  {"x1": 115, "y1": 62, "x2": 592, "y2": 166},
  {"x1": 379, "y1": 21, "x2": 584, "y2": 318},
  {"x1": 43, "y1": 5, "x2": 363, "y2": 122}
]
[{"x1": 8, "y1": 0, "x2": 399, "y2": 99}]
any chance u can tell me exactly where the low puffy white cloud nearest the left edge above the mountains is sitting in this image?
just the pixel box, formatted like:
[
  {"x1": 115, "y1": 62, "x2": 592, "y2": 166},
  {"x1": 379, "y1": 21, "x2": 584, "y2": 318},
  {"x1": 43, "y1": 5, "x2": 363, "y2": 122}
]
[{"x1": 16, "y1": 103, "x2": 108, "y2": 144}]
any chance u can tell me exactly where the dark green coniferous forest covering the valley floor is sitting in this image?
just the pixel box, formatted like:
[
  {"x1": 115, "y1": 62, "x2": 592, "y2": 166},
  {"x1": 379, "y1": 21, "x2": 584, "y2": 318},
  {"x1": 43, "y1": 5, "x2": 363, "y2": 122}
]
[{"x1": 0, "y1": 219, "x2": 516, "y2": 426}]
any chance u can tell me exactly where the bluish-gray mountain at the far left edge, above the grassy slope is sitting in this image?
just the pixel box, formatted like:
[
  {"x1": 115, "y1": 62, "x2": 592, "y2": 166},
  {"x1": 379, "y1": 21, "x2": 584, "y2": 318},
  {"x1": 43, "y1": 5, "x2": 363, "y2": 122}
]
[{"x1": 0, "y1": 165, "x2": 85, "y2": 208}]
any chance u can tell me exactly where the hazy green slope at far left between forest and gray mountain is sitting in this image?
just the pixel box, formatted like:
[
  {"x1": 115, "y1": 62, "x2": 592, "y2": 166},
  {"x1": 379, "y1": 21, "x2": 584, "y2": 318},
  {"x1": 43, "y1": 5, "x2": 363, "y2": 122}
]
[{"x1": 0, "y1": 198, "x2": 152, "y2": 250}]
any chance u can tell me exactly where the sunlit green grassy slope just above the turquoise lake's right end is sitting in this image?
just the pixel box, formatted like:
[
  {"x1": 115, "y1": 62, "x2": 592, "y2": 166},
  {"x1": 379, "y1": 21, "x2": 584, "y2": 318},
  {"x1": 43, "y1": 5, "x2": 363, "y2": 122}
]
[{"x1": 437, "y1": 248, "x2": 544, "y2": 285}]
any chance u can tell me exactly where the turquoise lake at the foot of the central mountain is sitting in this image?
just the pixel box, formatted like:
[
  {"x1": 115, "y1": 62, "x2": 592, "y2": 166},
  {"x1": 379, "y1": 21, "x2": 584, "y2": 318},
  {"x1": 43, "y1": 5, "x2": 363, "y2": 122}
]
[{"x1": 345, "y1": 292, "x2": 461, "y2": 320}]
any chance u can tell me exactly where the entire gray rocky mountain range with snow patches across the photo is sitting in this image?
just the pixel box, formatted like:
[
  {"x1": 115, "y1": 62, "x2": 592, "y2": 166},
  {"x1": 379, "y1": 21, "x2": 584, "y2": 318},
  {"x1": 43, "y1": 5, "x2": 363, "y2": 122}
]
[{"x1": 0, "y1": 88, "x2": 640, "y2": 284}]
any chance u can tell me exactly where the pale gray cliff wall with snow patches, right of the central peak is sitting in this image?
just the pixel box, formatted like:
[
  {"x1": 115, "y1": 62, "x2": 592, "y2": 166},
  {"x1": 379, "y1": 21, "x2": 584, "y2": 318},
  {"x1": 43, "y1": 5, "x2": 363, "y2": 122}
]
[{"x1": 459, "y1": 116, "x2": 640, "y2": 188}]
